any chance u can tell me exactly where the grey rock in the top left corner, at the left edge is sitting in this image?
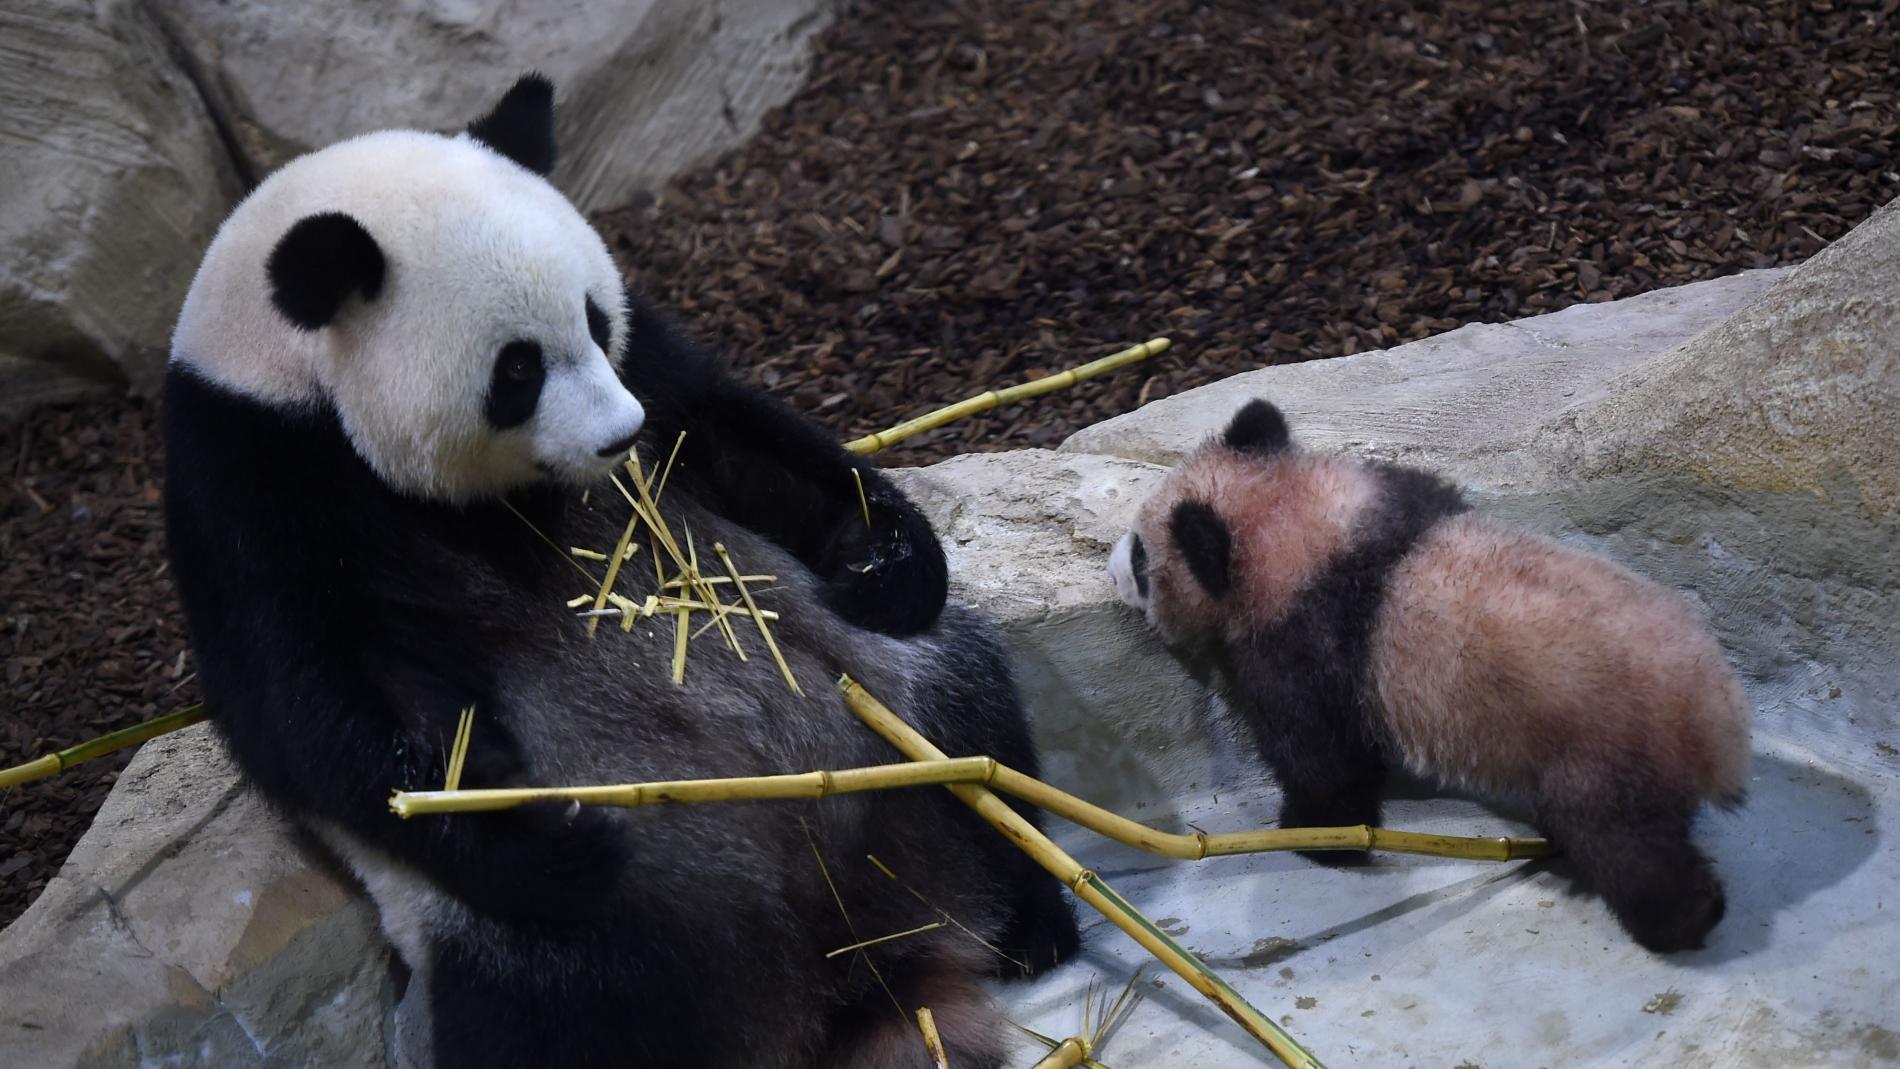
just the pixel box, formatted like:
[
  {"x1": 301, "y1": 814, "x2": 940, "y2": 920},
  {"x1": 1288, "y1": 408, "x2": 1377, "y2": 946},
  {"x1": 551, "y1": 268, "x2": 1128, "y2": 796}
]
[{"x1": 0, "y1": 0, "x2": 241, "y2": 418}]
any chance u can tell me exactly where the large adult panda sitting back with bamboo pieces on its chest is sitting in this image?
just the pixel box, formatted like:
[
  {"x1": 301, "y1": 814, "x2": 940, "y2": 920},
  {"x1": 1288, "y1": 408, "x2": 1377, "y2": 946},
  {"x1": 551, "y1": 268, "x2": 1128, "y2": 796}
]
[{"x1": 165, "y1": 76, "x2": 1077, "y2": 1069}]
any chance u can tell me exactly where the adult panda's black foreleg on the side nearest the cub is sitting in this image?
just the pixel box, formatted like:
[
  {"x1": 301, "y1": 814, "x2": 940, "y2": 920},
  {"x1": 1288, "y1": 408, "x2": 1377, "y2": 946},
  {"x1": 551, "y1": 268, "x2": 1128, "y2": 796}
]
[{"x1": 621, "y1": 296, "x2": 950, "y2": 636}]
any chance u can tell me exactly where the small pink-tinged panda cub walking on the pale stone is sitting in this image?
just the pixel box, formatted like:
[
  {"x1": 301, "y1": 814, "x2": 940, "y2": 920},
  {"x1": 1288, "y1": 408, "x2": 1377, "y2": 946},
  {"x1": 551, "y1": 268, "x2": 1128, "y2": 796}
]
[{"x1": 1110, "y1": 401, "x2": 1750, "y2": 953}]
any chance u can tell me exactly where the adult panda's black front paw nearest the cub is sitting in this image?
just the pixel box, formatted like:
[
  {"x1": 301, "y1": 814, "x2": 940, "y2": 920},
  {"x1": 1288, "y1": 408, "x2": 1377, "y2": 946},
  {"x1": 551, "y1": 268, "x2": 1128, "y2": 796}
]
[{"x1": 819, "y1": 490, "x2": 950, "y2": 636}]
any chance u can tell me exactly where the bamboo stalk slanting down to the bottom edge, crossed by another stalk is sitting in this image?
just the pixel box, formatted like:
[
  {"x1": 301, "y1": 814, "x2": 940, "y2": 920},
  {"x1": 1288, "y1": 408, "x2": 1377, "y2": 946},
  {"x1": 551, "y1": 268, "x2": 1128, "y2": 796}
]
[{"x1": 838, "y1": 676, "x2": 1321, "y2": 1069}]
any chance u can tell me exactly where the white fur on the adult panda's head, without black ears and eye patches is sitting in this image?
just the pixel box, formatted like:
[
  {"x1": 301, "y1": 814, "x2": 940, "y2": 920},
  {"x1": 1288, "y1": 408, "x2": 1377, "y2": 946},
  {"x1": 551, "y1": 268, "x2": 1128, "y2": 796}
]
[{"x1": 171, "y1": 131, "x2": 644, "y2": 501}]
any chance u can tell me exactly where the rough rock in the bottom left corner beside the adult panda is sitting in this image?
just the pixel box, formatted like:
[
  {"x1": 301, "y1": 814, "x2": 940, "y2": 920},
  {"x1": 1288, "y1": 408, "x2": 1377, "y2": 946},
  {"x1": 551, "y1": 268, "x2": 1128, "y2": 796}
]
[{"x1": 0, "y1": 725, "x2": 390, "y2": 1069}]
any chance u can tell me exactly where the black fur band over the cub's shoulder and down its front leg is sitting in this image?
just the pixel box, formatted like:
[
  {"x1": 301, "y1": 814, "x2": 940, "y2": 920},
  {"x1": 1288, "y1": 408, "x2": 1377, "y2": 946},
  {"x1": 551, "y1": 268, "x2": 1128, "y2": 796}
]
[{"x1": 1224, "y1": 465, "x2": 1467, "y2": 864}]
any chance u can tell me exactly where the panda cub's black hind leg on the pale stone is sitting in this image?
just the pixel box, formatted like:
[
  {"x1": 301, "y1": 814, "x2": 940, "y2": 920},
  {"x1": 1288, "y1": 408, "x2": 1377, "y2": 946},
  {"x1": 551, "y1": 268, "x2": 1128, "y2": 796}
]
[{"x1": 1537, "y1": 784, "x2": 1727, "y2": 953}]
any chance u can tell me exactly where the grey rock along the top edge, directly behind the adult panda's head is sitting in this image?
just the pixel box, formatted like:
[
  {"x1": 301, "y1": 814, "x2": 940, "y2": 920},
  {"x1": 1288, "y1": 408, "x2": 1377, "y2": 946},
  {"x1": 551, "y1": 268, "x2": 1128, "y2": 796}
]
[{"x1": 152, "y1": 0, "x2": 832, "y2": 211}]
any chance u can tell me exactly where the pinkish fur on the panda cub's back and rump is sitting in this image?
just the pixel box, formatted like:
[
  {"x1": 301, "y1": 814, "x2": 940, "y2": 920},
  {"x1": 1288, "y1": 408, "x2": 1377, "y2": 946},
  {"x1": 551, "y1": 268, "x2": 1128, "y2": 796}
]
[{"x1": 1372, "y1": 515, "x2": 1750, "y2": 801}]
